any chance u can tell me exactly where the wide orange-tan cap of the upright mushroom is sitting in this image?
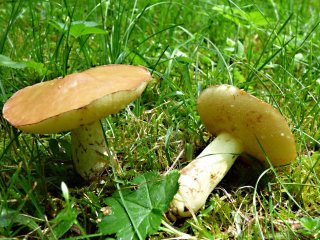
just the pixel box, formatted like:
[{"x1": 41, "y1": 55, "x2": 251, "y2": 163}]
[{"x1": 3, "y1": 64, "x2": 151, "y2": 134}]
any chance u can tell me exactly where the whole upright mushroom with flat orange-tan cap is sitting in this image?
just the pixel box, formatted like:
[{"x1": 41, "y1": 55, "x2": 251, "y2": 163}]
[{"x1": 3, "y1": 64, "x2": 151, "y2": 180}]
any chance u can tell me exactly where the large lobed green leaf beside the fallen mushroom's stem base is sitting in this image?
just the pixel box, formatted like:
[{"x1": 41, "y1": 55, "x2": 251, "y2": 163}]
[{"x1": 98, "y1": 171, "x2": 180, "y2": 240}]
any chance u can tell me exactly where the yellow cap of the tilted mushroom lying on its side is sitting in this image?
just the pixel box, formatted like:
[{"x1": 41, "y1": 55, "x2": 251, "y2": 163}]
[{"x1": 198, "y1": 85, "x2": 297, "y2": 166}]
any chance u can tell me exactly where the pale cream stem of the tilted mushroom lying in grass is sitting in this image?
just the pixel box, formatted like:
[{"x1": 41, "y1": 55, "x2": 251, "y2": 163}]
[{"x1": 171, "y1": 133, "x2": 243, "y2": 217}]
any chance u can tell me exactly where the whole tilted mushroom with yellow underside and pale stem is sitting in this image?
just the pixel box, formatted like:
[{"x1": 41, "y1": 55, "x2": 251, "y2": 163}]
[{"x1": 171, "y1": 85, "x2": 296, "y2": 217}]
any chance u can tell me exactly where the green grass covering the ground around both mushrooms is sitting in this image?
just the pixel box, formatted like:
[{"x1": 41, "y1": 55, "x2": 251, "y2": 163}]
[{"x1": 0, "y1": 0, "x2": 320, "y2": 239}]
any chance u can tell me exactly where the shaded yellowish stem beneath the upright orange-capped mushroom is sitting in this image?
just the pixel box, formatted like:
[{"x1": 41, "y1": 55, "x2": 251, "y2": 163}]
[{"x1": 71, "y1": 121, "x2": 109, "y2": 180}]
